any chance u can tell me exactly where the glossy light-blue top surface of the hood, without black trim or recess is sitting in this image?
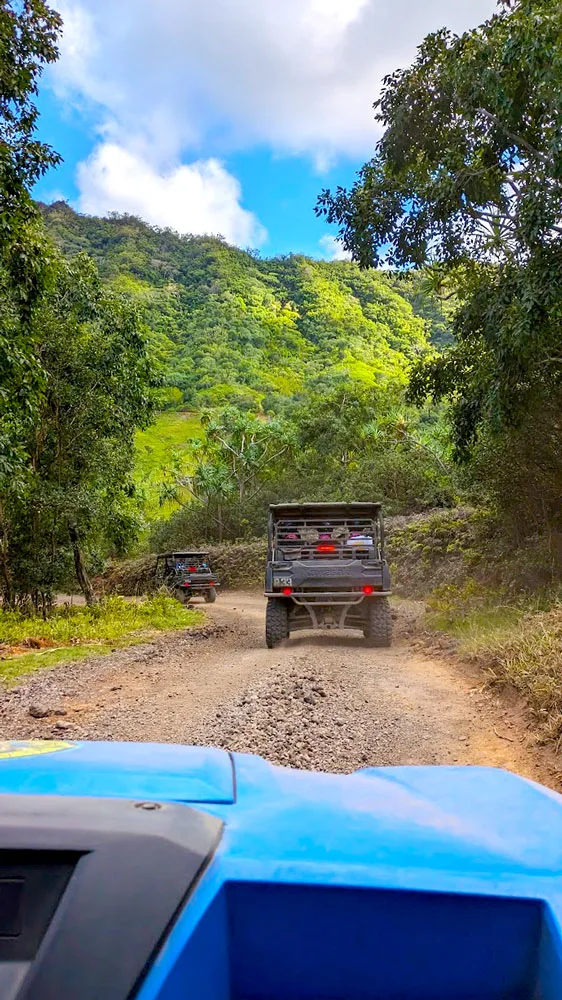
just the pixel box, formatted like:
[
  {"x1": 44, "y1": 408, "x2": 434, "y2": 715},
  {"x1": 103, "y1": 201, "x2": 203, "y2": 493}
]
[{"x1": 0, "y1": 741, "x2": 562, "y2": 872}]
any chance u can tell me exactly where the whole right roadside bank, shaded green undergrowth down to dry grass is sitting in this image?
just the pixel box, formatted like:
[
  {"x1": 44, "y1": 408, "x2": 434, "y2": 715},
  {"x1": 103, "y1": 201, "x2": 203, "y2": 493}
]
[{"x1": 389, "y1": 507, "x2": 562, "y2": 749}]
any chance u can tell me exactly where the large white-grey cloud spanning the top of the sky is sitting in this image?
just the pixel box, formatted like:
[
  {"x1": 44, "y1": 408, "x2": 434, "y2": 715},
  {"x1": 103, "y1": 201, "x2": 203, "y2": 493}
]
[{"x1": 51, "y1": 0, "x2": 496, "y2": 162}]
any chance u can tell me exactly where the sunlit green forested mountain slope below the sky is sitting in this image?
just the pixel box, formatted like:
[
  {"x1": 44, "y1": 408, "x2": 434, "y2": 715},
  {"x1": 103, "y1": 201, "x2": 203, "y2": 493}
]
[{"x1": 41, "y1": 202, "x2": 449, "y2": 412}]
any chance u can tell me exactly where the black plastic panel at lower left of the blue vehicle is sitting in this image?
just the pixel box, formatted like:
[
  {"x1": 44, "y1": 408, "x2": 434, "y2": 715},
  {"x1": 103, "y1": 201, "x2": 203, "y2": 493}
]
[{"x1": 0, "y1": 795, "x2": 222, "y2": 1000}]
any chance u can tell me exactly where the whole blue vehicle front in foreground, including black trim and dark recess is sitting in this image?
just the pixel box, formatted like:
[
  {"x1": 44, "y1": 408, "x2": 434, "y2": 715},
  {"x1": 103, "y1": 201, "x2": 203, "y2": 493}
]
[{"x1": 0, "y1": 741, "x2": 562, "y2": 1000}]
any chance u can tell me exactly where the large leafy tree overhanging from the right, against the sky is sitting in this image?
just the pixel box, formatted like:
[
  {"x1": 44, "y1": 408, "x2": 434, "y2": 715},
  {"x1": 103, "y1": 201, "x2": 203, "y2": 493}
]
[{"x1": 317, "y1": 0, "x2": 562, "y2": 458}]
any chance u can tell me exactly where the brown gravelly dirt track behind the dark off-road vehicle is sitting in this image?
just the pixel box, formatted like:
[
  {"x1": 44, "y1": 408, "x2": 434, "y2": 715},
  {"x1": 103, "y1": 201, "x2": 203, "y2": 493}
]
[{"x1": 0, "y1": 593, "x2": 559, "y2": 787}]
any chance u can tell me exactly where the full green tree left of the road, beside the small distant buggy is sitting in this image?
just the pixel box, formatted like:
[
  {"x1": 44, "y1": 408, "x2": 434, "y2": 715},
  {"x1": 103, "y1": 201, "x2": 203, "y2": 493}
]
[{"x1": 0, "y1": 254, "x2": 154, "y2": 604}]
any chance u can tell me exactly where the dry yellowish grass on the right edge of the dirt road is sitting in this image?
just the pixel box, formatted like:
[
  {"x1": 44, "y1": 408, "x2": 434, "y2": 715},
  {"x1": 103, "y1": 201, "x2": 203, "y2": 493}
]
[{"x1": 426, "y1": 591, "x2": 562, "y2": 750}]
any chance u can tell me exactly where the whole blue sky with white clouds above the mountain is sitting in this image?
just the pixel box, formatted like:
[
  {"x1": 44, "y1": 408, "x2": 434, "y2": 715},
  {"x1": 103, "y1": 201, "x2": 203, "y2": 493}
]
[{"x1": 32, "y1": 0, "x2": 495, "y2": 258}]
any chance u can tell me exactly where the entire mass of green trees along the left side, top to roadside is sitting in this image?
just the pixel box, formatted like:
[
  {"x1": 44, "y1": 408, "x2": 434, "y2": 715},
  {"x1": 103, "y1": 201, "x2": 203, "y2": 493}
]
[{"x1": 0, "y1": 0, "x2": 156, "y2": 610}]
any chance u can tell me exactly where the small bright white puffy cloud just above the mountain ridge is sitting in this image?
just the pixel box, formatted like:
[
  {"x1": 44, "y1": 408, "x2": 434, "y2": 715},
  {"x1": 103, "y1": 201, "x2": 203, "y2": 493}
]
[{"x1": 77, "y1": 142, "x2": 267, "y2": 247}]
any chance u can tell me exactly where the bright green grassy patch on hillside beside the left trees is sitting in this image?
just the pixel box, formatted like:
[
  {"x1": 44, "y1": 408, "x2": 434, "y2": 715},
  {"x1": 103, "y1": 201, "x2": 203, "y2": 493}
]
[{"x1": 135, "y1": 410, "x2": 203, "y2": 520}]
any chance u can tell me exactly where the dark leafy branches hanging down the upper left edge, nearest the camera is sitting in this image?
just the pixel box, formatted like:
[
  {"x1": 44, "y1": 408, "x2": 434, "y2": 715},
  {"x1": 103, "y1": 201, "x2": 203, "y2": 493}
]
[{"x1": 0, "y1": 0, "x2": 62, "y2": 476}]
